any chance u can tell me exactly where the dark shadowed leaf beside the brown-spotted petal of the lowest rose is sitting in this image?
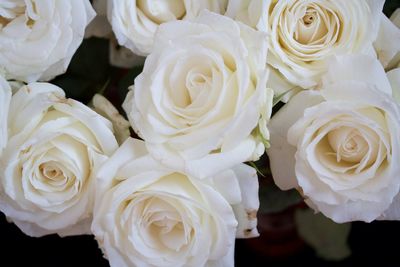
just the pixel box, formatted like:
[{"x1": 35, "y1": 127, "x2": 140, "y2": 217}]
[{"x1": 259, "y1": 181, "x2": 303, "y2": 213}]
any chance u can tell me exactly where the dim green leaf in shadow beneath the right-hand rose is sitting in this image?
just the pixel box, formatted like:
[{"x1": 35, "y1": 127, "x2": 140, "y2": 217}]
[{"x1": 295, "y1": 209, "x2": 351, "y2": 261}]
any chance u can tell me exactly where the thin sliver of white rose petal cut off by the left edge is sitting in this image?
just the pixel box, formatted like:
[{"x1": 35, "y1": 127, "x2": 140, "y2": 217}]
[{"x1": 0, "y1": 76, "x2": 11, "y2": 156}]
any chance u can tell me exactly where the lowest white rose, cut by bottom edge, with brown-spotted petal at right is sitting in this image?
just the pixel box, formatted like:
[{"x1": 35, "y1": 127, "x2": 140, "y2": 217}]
[{"x1": 92, "y1": 138, "x2": 259, "y2": 267}]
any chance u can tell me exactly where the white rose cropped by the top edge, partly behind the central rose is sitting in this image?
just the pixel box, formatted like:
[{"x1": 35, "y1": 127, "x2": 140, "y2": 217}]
[{"x1": 108, "y1": 0, "x2": 228, "y2": 56}]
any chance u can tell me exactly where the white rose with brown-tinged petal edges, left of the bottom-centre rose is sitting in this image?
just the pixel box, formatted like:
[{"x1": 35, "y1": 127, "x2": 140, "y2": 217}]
[{"x1": 0, "y1": 83, "x2": 118, "y2": 236}]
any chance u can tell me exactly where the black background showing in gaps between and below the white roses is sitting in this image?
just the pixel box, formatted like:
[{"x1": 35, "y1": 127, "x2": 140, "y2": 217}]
[{"x1": 0, "y1": 0, "x2": 400, "y2": 267}]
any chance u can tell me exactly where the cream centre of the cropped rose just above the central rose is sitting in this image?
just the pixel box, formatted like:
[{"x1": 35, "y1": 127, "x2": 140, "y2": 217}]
[{"x1": 136, "y1": 0, "x2": 186, "y2": 24}]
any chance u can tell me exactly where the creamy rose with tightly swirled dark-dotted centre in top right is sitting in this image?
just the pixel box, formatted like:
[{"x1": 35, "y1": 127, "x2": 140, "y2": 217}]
[{"x1": 227, "y1": 0, "x2": 400, "y2": 89}]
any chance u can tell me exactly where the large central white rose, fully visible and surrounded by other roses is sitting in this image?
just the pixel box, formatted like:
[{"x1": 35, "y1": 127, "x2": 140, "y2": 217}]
[{"x1": 123, "y1": 12, "x2": 273, "y2": 180}]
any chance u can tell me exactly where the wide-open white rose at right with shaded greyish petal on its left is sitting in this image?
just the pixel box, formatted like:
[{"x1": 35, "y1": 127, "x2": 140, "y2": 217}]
[{"x1": 268, "y1": 55, "x2": 400, "y2": 222}]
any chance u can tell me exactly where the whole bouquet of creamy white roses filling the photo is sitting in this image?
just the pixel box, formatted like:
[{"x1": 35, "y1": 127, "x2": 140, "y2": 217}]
[{"x1": 0, "y1": 0, "x2": 400, "y2": 266}]
